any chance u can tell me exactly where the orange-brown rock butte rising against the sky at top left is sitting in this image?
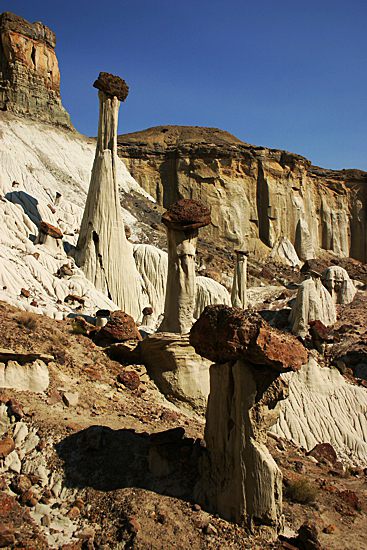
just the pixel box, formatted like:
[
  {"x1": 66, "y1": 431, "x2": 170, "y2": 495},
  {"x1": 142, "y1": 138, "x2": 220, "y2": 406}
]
[{"x1": 0, "y1": 12, "x2": 73, "y2": 128}]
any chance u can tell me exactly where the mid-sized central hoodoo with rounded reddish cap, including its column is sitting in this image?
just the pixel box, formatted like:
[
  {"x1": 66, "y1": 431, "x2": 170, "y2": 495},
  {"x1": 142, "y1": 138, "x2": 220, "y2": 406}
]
[{"x1": 159, "y1": 199, "x2": 211, "y2": 334}]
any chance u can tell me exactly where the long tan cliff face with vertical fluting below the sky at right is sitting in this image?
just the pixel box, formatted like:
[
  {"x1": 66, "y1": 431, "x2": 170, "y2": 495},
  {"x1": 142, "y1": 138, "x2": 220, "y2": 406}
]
[{"x1": 118, "y1": 126, "x2": 367, "y2": 262}]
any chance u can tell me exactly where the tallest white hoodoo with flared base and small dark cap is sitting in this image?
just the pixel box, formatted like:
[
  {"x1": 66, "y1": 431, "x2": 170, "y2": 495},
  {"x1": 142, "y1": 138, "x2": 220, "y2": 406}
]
[{"x1": 75, "y1": 73, "x2": 145, "y2": 320}]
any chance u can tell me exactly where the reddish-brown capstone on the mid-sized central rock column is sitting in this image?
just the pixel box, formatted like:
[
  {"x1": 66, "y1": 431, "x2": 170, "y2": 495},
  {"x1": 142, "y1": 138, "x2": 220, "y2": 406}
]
[{"x1": 162, "y1": 199, "x2": 211, "y2": 231}]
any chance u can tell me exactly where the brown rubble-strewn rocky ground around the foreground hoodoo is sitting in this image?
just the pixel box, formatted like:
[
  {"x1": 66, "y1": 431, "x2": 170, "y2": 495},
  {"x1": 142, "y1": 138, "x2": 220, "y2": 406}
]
[{"x1": 0, "y1": 303, "x2": 367, "y2": 550}]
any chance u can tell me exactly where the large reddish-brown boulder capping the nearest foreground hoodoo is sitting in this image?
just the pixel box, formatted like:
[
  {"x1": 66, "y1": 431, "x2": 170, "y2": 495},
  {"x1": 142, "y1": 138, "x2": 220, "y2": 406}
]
[{"x1": 190, "y1": 305, "x2": 307, "y2": 372}]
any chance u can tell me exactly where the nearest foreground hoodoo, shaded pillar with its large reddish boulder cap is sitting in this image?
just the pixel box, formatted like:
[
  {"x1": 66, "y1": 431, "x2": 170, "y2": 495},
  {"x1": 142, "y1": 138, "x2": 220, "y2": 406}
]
[{"x1": 190, "y1": 306, "x2": 307, "y2": 536}]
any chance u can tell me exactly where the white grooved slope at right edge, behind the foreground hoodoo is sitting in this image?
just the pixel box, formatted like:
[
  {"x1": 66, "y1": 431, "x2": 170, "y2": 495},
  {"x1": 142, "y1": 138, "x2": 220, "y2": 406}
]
[{"x1": 271, "y1": 357, "x2": 367, "y2": 467}]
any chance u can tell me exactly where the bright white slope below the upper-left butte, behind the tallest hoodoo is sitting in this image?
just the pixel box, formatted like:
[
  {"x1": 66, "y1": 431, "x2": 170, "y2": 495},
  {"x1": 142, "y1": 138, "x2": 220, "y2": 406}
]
[{"x1": 0, "y1": 114, "x2": 148, "y2": 318}]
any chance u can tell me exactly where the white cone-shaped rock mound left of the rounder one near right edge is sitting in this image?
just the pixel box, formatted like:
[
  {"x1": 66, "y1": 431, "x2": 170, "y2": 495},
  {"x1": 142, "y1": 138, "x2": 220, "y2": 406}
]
[{"x1": 289, "y1": 278, "x2": 336, "y2": 337}]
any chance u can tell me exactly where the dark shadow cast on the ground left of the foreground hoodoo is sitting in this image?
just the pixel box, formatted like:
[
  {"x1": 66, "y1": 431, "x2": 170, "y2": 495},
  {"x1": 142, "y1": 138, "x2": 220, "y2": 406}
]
[{"x1": 55, "y1": 426, "x2": 201, "y2": 500}]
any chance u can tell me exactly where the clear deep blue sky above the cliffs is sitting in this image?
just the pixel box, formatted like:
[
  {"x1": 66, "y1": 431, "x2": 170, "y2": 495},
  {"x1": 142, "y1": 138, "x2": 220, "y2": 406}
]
[{"x1": 5, "y1": 0, "x2": 367, "y2": 170}]
